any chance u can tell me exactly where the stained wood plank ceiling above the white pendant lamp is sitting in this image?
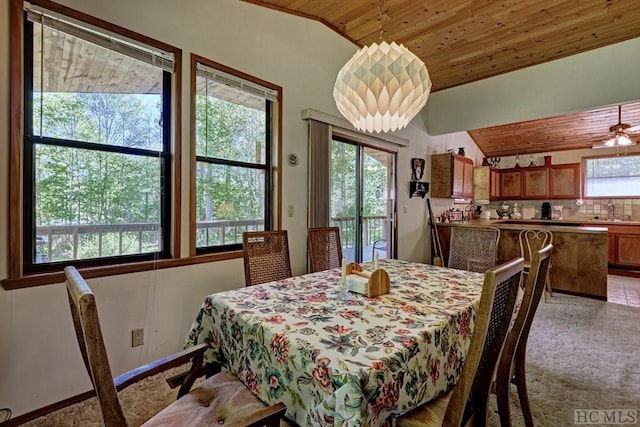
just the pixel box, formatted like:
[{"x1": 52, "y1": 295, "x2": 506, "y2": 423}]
[{"x1": 244, "y1": 0, "x2": 640, "y2": 91}]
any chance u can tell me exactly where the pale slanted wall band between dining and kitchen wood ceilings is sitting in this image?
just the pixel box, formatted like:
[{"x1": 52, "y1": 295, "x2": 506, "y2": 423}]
[{"x1": 422, "y1": 38, "x2": 640, "y2": 135}]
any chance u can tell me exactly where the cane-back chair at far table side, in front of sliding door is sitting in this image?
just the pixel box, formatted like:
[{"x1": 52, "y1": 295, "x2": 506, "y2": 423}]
[{"x1": 307, "y1": 227, "x2": 342, "y2": 273}]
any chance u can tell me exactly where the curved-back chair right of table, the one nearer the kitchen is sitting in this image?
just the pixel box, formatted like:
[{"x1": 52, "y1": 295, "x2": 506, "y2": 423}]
[{"x1": 495, "y1": 244, "x2": 553, "y2": 427}]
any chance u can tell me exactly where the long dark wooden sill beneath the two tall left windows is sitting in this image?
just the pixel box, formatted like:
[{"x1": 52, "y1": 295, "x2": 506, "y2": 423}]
[{"x1": 2, "y1": 251, "x2": 242, "y2": 291}]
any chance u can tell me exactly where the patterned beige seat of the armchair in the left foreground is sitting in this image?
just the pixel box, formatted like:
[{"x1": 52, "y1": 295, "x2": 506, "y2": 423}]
[{"x1": 143, "y1": 371, "x2": 285, "y2": 427}]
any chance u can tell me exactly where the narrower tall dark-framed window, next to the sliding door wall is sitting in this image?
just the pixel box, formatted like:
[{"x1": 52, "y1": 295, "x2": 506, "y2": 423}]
[{"x1": 192, "y1": 55, "x2": 279, "y2": 253}]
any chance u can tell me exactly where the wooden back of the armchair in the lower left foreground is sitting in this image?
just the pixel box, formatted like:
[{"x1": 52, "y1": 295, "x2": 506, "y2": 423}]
[{"x1": 64, "y1": 267, "x2": 127, "y2": 426}]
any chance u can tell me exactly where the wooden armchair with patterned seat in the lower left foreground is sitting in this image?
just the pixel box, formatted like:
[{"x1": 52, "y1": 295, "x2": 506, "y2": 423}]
[{"x1": 64, "y1": 266, "x2": 286, "y2": 427}]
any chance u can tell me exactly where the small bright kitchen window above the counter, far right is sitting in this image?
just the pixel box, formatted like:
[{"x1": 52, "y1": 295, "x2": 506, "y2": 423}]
[{"x1": 584, "y1": 155, "x2": 640, "y2": 197}]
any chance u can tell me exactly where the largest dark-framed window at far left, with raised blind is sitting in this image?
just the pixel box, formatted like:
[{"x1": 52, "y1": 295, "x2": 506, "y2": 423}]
[{"x1": 22, "y1": 1, "x2": 173, "y2": 272}]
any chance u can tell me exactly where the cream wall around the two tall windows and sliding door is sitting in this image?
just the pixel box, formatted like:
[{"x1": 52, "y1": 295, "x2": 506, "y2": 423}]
[{"x1": 0, "y1": 0, "x2": 440, "y2": 416}]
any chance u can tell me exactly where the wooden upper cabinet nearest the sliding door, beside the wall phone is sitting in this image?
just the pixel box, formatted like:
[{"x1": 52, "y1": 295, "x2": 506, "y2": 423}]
[{"x1": 431, "y1": 153, "x2": 473, "y2": 198}]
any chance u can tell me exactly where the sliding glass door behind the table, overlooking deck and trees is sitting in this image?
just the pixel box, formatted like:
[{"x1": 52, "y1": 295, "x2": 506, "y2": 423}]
[{"x1": 330, "y1": 137, "x2": 395, "y2": 262}]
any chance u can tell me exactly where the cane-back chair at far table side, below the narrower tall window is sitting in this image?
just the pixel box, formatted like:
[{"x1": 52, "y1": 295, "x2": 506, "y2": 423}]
[{"x1": 242, "y1": 230, "x2": 292, "y2": 286}]
